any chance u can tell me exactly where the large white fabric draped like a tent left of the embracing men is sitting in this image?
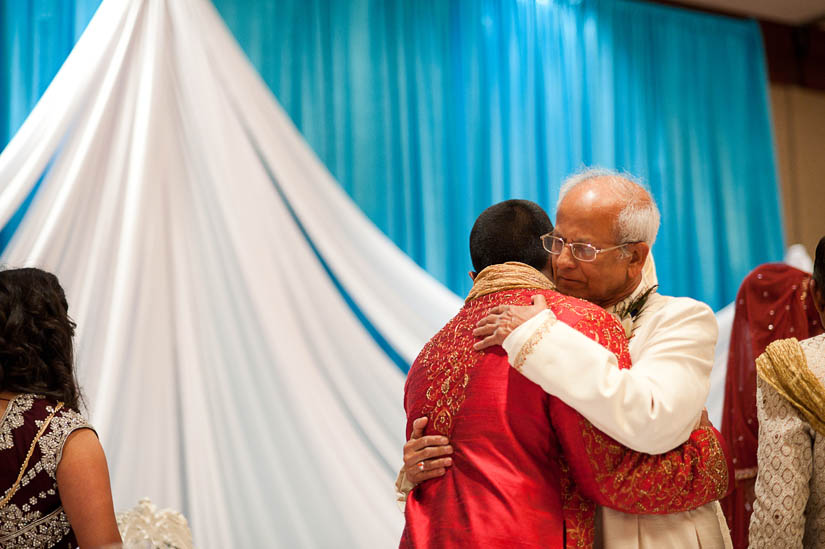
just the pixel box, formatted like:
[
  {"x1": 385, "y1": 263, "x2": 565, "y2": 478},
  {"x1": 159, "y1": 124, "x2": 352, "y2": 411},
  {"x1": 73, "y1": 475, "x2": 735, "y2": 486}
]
[{"x1": 0, "y1": 0, "x2": 460, "y2": 548}]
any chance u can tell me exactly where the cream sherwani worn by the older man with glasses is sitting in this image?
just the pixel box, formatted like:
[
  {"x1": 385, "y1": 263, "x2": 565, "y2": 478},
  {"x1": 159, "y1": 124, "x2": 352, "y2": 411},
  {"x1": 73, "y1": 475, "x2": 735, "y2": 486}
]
[{"x1": 503, "y1": 282, "x2": 731, "y2": 549}]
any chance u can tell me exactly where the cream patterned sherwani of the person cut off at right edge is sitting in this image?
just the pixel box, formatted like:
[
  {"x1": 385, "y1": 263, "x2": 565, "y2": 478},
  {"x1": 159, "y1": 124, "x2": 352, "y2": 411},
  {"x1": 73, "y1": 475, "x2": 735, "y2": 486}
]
[{"x1": 749, "y1": 334, "x2": 825, "y2": 549}]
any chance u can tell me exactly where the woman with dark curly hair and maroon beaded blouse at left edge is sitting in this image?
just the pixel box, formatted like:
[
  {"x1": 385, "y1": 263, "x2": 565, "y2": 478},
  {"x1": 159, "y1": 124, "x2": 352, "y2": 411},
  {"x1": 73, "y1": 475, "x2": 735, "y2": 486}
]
[{"x1": 0, "y1": 269, "x2": 121, "y2": 549}]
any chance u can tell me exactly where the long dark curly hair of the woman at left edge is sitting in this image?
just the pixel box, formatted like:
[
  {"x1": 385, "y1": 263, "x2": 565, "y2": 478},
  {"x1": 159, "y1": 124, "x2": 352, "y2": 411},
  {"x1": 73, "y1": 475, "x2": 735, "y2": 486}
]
[{"x1": 0, "y1": 268, "x2": 82, "y2": 410}]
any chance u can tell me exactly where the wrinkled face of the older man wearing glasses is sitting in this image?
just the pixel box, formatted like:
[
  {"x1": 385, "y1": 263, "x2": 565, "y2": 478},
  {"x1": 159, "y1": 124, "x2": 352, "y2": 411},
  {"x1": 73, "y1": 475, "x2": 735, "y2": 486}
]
[{"x1": 552, "y1": 183, "x2": 647, "y2": 307}]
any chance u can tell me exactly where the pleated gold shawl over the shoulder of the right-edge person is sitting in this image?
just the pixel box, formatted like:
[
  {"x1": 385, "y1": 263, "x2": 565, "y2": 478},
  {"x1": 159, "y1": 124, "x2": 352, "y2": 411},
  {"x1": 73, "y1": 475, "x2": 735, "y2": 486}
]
[{"x1": 756, "y1": 337, "x2": 825, "y2": 435}]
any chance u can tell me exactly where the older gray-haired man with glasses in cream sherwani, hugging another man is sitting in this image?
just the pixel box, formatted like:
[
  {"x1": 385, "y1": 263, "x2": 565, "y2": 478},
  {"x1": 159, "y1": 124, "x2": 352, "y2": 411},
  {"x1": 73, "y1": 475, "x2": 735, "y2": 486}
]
[{"x1": 405, "y1": 169, "x2": 731, "y2": 549}]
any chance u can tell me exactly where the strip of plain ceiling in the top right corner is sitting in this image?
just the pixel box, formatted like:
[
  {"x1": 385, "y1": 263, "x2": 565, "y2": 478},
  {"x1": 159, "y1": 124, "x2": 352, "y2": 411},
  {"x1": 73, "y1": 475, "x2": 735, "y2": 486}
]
[{"x1": 677, "y1": 0, "x2": 825, "y2": 25}]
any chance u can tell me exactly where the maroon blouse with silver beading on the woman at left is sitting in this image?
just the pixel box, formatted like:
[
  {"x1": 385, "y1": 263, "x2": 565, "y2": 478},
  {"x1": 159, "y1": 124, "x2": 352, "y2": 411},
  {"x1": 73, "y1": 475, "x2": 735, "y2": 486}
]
[{"x1": 0, "y1": 394, "x2": 92, "y2": 549}]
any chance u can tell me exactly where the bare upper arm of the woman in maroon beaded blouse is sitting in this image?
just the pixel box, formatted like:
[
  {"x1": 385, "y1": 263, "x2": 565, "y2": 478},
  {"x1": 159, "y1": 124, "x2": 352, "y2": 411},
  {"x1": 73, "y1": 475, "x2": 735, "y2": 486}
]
[{"x1": 57, "y1": 429, "x2": 121, "y2": 547}]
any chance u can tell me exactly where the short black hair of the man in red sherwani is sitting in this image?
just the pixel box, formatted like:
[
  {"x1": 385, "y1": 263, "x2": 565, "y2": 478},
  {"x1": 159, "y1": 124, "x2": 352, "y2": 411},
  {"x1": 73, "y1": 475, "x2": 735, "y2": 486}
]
[{"x1": 470, "y1": 199, "x2": 553, "y2": 273}]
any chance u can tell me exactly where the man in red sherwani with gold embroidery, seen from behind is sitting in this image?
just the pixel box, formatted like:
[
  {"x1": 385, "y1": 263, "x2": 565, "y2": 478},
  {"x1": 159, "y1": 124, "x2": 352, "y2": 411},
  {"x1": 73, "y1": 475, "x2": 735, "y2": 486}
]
[{"x1": 401, "y1": 200, "x2": 733, "y2": 548}]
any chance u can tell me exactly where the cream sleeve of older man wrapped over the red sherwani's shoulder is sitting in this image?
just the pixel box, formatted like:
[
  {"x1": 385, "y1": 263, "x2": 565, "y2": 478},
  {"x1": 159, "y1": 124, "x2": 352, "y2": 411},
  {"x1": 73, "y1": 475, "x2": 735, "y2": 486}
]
[{"x1": 503, "y1": 294, "x2": 718, "y2": 454}]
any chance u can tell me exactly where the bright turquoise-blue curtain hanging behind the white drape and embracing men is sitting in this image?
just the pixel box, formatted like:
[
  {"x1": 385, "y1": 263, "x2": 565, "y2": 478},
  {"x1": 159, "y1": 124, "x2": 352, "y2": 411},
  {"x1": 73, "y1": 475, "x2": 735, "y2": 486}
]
[{"x1": 0, "y1": 0, "x2": 784, "y2": 308}]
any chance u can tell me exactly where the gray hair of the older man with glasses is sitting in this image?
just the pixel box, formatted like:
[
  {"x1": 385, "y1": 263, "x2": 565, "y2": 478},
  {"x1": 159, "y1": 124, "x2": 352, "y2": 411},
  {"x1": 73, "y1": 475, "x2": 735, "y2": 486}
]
[{"x1": 556, "y1": 168, "x2": 659, "y2": 246}]
